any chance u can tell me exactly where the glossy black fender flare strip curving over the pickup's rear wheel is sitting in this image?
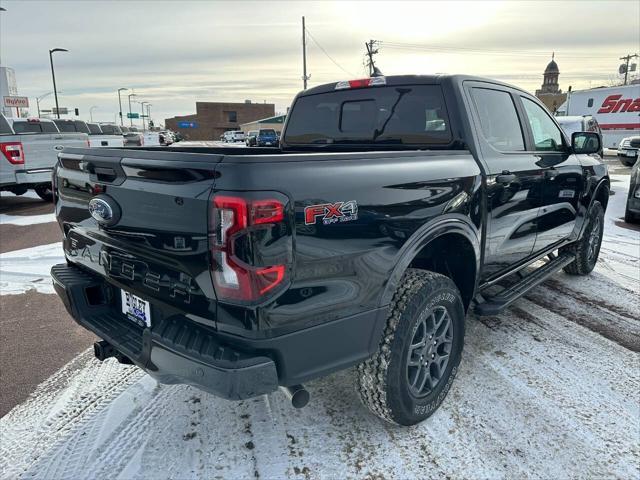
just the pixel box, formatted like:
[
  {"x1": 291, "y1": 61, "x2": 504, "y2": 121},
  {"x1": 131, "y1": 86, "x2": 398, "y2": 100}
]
[{"x1": 380, "y1": 214, "x2": 481, "y2": 306}]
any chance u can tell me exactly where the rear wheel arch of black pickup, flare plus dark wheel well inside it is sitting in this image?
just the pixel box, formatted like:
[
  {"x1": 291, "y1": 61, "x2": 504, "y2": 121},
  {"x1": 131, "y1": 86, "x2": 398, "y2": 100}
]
[{"x1": 381, "y1": 215, "x2": 481, "y2": 310}]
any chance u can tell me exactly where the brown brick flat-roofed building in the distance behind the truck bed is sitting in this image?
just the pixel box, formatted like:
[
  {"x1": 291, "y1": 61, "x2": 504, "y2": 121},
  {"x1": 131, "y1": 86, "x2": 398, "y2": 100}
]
[{"x1": 164, "y1": 100, "x2": 276, "y2": 140}]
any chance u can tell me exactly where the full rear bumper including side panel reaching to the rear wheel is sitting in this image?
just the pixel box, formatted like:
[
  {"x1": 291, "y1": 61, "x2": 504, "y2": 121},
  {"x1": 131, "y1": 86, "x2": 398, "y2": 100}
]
[{"x1": 51, "y1": 264, "x2": 387, "y2": 400}]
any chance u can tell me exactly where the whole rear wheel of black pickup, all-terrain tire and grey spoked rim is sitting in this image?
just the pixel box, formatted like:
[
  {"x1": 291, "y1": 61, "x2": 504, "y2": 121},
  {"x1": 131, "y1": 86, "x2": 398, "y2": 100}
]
[{"x1": 356, "y1": 269, "x2": 464, "y2": 425}]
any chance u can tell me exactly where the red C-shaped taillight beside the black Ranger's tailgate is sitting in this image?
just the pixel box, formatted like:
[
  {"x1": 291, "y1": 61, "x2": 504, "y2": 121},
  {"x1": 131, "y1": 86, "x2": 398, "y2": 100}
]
[{"x1": 210, "y1": 195, "x2": 287, "y2": 302}]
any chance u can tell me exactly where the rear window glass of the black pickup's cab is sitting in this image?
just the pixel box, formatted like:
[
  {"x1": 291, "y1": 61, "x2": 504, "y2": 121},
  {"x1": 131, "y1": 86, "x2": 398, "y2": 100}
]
[{"x1": 285, "y1": 85, "x2": 452, "y2": 145}]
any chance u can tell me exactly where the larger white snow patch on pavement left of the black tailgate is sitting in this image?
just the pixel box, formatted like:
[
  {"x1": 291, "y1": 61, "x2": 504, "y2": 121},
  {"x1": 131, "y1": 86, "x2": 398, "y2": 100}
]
[{"x1": 0, "y1": 242, "x2": 65, "y2": 295}]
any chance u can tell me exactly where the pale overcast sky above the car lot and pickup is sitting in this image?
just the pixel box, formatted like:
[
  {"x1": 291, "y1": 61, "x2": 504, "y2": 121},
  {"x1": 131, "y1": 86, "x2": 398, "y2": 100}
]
[{"x1": 0, "y1": 0, "x2": 640, "y2": 123}]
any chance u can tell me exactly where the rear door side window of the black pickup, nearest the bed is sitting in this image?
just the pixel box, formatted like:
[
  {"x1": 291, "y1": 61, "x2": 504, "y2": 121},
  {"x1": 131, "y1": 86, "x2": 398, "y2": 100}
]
[{"x1": 471, "y1": 88, "x2": 524, "y2": 152}]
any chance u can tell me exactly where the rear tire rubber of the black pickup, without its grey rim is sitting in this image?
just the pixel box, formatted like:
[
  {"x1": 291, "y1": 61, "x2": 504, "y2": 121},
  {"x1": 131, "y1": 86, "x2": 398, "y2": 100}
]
[{"x1": 356, "y1": 269, "x2": 465, "y2": 425}]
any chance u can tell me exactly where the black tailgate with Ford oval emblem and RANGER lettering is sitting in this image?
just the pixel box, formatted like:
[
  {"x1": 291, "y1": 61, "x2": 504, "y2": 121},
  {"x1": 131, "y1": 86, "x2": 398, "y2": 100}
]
[{"x1": 55, "y1": 149, "x2": 225, "y2": 323}]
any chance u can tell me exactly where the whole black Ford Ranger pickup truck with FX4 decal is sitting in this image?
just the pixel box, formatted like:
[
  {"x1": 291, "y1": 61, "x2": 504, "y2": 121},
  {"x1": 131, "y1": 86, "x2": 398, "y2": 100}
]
[{"x1": 52, "y1": 76, "x2": 609, "y2": 425}]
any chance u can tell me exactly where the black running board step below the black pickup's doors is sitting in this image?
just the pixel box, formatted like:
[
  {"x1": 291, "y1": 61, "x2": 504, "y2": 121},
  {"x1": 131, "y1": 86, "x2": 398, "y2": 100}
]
[{"x1": 474, "y1": 253, "x2": 575, "y2": 315}]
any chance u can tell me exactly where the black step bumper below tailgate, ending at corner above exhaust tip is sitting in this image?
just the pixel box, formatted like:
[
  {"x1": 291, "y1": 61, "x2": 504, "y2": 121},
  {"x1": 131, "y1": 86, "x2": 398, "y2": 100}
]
[{"x1": 51, "y1": 264, "x2": 278, "y2": 400}]
